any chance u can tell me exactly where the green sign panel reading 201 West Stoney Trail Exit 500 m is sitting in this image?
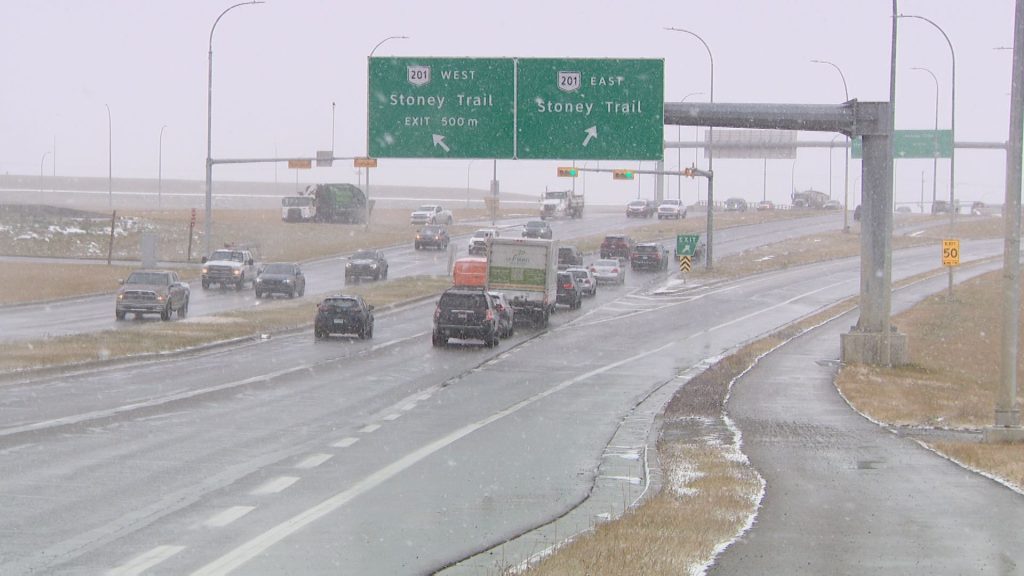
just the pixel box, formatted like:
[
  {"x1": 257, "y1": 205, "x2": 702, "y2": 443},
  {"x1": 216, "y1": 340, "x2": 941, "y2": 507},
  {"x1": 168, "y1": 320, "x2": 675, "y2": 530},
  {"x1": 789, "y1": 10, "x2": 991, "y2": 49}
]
[{"x1": 368, "y1": 57, "x2": 515, "y2": 158}]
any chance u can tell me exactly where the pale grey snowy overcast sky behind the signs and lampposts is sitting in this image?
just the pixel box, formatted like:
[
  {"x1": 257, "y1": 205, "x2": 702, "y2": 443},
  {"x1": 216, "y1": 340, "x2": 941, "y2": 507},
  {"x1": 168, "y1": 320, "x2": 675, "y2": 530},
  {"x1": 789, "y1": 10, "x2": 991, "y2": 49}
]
[{"x1": 0, "y1": 0, "x2": 1014, "y2": 204}]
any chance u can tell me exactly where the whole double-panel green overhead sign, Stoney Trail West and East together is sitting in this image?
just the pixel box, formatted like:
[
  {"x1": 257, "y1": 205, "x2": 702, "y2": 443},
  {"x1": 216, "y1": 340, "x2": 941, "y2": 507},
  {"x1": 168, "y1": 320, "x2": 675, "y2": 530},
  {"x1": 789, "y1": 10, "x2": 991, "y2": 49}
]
[{"x1": 367, "y1": 57, "x2": 665, "y2": 160}]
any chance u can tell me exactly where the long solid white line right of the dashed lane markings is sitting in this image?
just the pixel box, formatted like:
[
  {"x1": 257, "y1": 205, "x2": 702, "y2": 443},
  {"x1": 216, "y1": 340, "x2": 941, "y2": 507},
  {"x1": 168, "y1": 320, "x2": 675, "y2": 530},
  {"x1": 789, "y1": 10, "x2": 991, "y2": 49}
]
[{"x1": 191, "y1": 342, "x2": 676, "y2": 576}]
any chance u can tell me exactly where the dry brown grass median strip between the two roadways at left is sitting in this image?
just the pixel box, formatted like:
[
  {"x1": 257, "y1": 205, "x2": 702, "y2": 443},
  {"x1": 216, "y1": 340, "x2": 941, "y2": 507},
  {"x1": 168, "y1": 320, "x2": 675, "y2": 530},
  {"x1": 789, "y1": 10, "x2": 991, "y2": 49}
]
[{"x1": 0, "y1": 277, "x2": 452, "y2": 371}]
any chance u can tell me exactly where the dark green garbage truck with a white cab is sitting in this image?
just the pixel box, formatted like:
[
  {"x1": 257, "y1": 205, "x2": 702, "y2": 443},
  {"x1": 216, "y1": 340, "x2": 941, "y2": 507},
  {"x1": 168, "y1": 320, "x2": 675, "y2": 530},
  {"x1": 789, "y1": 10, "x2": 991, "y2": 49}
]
[{"x1": 281, "y1": 183, "x2": 374, "y2": 224}]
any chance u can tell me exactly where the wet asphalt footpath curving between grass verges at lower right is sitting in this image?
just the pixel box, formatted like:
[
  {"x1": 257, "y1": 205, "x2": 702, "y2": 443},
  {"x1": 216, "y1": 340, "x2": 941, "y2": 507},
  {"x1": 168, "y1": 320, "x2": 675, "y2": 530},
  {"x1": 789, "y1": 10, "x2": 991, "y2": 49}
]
[{"x1": 710, "y1": 262, "x2": 1024, "y2": 576}]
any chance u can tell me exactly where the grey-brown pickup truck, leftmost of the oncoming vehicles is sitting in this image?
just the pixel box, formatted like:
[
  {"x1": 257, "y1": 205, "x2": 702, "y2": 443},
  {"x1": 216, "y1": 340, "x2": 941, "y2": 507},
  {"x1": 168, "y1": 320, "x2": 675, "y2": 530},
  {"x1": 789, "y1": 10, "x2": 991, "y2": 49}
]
[{"x1": 114, "y1": 270, "x2": 190, "y2": 321}]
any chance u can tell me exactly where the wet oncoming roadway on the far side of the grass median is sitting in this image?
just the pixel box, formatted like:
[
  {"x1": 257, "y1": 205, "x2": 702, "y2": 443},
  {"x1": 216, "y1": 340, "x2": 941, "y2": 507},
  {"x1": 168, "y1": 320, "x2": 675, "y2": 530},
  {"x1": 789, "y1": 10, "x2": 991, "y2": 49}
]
[{"x1": 0, "y1": 213, "x2": 842, "y2": 341}]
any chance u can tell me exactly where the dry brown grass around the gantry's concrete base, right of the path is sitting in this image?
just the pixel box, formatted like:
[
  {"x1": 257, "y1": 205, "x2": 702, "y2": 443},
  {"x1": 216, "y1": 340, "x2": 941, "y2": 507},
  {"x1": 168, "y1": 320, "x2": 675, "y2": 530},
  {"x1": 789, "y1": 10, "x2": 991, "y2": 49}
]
[{"x1": 837, "y1": 272, "x2": 1024, "y2": 428}]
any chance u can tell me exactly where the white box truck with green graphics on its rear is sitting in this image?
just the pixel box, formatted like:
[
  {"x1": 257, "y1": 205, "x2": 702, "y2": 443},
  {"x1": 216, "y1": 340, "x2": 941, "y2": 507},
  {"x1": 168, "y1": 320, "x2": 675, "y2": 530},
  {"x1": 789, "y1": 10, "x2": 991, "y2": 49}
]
[{"x1": 486, "y1": 238, "x2": 558, "y2": 328}]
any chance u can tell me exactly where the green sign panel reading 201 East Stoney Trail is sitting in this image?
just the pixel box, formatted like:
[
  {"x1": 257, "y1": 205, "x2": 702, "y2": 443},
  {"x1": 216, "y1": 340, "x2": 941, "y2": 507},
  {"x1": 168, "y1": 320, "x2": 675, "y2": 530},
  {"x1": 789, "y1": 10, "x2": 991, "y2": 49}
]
[{"x1": 516, "y1": 58, "x2": 665, "y2": 160}]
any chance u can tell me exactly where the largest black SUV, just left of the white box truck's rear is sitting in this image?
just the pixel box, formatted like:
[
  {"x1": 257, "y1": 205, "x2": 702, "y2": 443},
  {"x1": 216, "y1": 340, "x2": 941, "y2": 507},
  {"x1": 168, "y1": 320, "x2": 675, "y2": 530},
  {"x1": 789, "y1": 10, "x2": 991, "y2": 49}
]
[{"x1": 430, "y1": 286, "x2": 499, "y2": 347}]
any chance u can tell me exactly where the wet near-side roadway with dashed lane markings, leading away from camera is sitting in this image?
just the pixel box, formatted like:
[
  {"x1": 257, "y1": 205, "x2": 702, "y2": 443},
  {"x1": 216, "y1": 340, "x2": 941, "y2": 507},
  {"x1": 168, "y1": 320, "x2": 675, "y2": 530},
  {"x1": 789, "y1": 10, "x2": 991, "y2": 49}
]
[{"x1": 0, "y1": 235, "x2": 1001, "y2": 574}]
